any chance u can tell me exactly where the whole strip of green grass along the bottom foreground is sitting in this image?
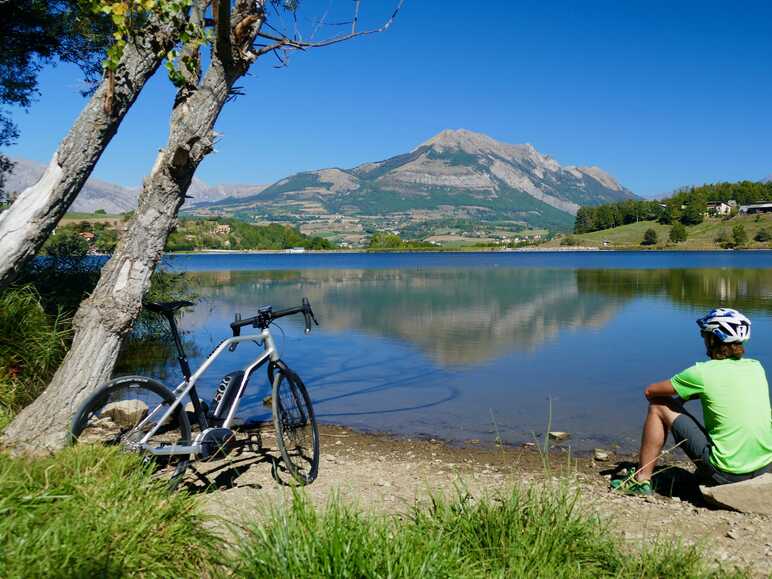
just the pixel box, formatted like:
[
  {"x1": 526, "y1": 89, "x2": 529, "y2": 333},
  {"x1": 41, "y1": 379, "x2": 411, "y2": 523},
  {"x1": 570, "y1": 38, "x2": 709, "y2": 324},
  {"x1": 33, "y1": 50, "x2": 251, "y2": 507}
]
[{"x1": 0, "y1": 447, "x2": 742, "y2": 577}]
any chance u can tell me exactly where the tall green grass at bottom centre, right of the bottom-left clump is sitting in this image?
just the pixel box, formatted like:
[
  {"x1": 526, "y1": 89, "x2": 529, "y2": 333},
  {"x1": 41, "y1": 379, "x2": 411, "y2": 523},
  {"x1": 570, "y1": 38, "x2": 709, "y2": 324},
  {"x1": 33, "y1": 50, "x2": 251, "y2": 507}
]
[{"x1": 235, "y1": 489, "x2": 740, "y2": 578}]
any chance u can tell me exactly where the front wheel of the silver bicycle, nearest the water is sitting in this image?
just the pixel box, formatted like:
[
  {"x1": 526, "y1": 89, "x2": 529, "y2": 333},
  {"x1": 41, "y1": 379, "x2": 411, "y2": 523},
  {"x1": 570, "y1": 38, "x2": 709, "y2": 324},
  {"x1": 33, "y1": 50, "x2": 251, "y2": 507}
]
[{"x1": 270, "y1": 363, "x2": 319, "y2": 485}]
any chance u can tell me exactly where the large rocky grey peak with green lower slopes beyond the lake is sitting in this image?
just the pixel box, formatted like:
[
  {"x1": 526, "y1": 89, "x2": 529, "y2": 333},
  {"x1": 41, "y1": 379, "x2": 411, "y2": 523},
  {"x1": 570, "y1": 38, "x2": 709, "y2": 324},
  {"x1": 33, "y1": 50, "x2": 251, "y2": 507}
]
[{"x1": 188, "y1": 129, "x2": 636, "y2": 237}]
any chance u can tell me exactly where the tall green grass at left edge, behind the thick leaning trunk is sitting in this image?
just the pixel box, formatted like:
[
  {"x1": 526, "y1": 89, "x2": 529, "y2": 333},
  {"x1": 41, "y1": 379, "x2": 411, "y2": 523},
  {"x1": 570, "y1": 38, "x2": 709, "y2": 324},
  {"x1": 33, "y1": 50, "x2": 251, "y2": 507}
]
[{"x1": 0, "y1": 286, "x2": 72, "y2": 430}]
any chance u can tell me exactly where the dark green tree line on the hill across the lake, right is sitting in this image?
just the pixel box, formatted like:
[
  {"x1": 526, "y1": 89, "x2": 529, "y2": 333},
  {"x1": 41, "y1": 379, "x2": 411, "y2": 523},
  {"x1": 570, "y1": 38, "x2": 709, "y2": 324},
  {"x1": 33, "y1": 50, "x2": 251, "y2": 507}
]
[{"x1": 574, "y1": 181, "x2": 772, "y2": 233}]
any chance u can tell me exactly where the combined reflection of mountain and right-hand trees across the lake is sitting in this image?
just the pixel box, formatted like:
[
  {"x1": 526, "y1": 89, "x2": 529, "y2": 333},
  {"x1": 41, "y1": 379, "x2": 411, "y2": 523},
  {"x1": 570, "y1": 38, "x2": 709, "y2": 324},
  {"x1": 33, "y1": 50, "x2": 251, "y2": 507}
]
[{"x1": 178, "y1": 269, "x2": 772, "y2": 365}]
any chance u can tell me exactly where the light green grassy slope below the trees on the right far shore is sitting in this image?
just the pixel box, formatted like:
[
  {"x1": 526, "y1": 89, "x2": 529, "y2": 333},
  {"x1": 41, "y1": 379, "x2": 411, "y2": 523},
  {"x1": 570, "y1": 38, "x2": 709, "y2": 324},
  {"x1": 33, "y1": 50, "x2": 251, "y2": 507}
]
[{"x1": 554, "y1": 214, "x2": 772, "y2": 249}]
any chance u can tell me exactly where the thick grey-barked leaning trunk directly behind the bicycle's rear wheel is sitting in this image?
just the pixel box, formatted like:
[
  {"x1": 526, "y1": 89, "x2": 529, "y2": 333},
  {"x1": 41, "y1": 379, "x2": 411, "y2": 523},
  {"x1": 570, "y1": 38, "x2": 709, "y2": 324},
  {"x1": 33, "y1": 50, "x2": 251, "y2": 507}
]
[{"x1": 3, "y1": 0, "x2": 263, "y2": 453}]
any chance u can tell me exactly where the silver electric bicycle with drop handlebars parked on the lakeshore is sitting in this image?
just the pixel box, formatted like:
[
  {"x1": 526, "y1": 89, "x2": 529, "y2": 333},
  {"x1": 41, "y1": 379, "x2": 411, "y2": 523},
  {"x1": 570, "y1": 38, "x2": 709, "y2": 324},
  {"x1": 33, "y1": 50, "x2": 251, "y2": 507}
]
[{"x1": 71, "y1": 298, "x2": 319, "y2": 485}]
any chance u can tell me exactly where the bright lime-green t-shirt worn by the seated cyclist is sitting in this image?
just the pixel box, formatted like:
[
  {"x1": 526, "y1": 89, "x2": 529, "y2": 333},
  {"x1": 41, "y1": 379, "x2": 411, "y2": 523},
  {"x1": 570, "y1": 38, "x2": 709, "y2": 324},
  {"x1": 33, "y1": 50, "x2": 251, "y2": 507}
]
[{"x1": 671, "y1": 358, "x2": 772, "y2": 474}]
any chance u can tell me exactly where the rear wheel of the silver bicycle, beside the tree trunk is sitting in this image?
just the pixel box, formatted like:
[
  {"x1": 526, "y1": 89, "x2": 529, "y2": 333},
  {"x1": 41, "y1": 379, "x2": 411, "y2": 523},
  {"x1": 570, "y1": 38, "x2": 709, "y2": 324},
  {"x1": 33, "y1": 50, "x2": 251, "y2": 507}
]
[{"x1": 70, "y1": 376, "x2": 191, "y2": 486}]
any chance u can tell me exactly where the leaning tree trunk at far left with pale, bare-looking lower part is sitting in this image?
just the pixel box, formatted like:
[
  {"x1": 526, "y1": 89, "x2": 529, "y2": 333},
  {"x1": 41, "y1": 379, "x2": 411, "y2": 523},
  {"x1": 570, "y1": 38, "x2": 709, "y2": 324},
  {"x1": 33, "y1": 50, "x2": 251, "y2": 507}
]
[{"x1": 0, "y1": 19, "x2": 182, "y2": 288}]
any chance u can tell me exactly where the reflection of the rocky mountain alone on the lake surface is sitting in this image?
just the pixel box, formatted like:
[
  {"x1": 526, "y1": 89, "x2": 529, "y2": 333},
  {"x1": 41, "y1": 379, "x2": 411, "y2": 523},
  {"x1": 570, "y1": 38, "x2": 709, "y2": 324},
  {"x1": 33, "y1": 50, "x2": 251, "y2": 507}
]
[{"x1": 188, "y1": 269, "x2": 624, "y2": 364}]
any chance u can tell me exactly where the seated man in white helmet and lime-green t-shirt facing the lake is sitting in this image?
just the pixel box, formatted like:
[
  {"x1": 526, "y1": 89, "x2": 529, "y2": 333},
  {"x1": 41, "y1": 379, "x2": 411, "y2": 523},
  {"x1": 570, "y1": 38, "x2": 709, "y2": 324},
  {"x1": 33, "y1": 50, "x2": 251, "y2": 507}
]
[{"x1": 611, "y1": 308, "x2": 772, "y2": 495}]
